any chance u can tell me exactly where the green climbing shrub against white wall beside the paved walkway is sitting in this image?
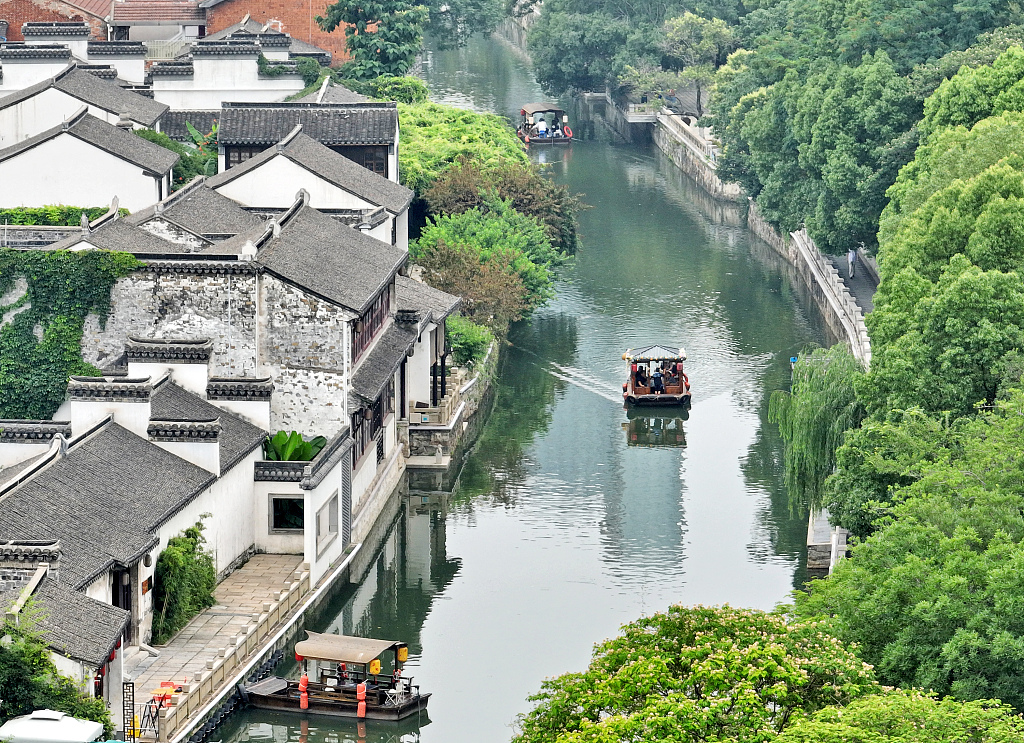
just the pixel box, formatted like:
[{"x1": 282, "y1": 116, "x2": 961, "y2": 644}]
[{"x1": 153, "y1": 519, "x2": 217, "y2": 645}]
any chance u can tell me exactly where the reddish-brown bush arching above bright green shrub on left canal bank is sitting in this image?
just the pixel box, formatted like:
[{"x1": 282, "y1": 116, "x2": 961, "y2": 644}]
[{"x1": 423, "y1": 157, "x2": 582, "y2": 255}]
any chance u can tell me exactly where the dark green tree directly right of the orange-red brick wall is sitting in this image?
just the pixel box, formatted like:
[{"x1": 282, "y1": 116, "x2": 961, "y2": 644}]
[{"x1": 316, "y1": 0, "x2": 428, "y2": 80}]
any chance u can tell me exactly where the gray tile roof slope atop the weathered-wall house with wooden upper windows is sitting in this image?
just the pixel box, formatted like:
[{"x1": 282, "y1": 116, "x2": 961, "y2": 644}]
[{"x1": 256, "y1": 207, "x2": 408, "y2": 313}]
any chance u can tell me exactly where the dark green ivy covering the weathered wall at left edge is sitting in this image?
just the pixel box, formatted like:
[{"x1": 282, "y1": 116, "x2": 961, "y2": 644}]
[{"x1": 0, "y1": 249, "x2": 141, "y2": 419}]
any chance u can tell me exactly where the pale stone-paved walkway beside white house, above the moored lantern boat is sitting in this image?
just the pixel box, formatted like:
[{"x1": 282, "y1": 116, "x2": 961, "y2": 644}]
[{"x1": 125, "y1": 555, "x2": 302, "y2": 701}]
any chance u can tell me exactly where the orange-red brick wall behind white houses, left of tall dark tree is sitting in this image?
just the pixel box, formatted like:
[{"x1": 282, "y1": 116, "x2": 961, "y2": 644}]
[{"x1": 202, "y1": 0, "x2": 348, "y2": 67}]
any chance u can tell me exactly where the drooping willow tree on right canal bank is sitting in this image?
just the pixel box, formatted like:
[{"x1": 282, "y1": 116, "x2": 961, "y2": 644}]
[{"x1": 768, "y1": 345, "x2": 864, "y2": 508}]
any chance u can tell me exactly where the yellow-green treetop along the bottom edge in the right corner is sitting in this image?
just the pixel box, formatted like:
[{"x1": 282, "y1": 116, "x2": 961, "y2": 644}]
[{"x1": 775, "y1": 690, "x2": 1024, "y2": 743}]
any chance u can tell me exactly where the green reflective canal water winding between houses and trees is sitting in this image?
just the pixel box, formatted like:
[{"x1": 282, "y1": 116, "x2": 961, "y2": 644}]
[{"x1": 214, "y1": 31, "x2": 825, "y2": 743}]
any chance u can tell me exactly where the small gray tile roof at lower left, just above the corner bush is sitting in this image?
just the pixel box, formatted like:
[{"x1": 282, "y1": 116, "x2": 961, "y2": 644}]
[{"x1": 33, "y1": 578, "x2": 131, "y2": 668}]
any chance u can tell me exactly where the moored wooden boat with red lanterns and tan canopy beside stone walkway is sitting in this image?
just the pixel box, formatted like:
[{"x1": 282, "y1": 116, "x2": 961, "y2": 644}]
[{"x1": 241, "y1": 630, "x2": 430, "y2": 720}]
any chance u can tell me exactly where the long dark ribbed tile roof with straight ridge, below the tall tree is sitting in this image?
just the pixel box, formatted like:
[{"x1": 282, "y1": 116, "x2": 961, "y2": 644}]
[{"x1": 219, "y1": 103, "x2": 398, "y2": 146}]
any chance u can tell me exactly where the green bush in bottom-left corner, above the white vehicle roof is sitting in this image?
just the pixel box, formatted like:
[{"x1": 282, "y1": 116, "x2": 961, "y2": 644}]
[{"x1": 0, "y1": 614, "x2": 114, "y2": 736}]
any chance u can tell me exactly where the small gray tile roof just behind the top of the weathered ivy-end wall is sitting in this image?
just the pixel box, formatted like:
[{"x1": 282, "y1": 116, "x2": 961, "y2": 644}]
[{"x1": 124, "y1": 178, "x2": 262, "y2": 237}]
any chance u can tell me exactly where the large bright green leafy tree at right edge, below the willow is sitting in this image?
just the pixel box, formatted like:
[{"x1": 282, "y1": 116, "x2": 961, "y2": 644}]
[{"x1": 796, "y1": 390, "x2": 1024, "y2": 709}]
